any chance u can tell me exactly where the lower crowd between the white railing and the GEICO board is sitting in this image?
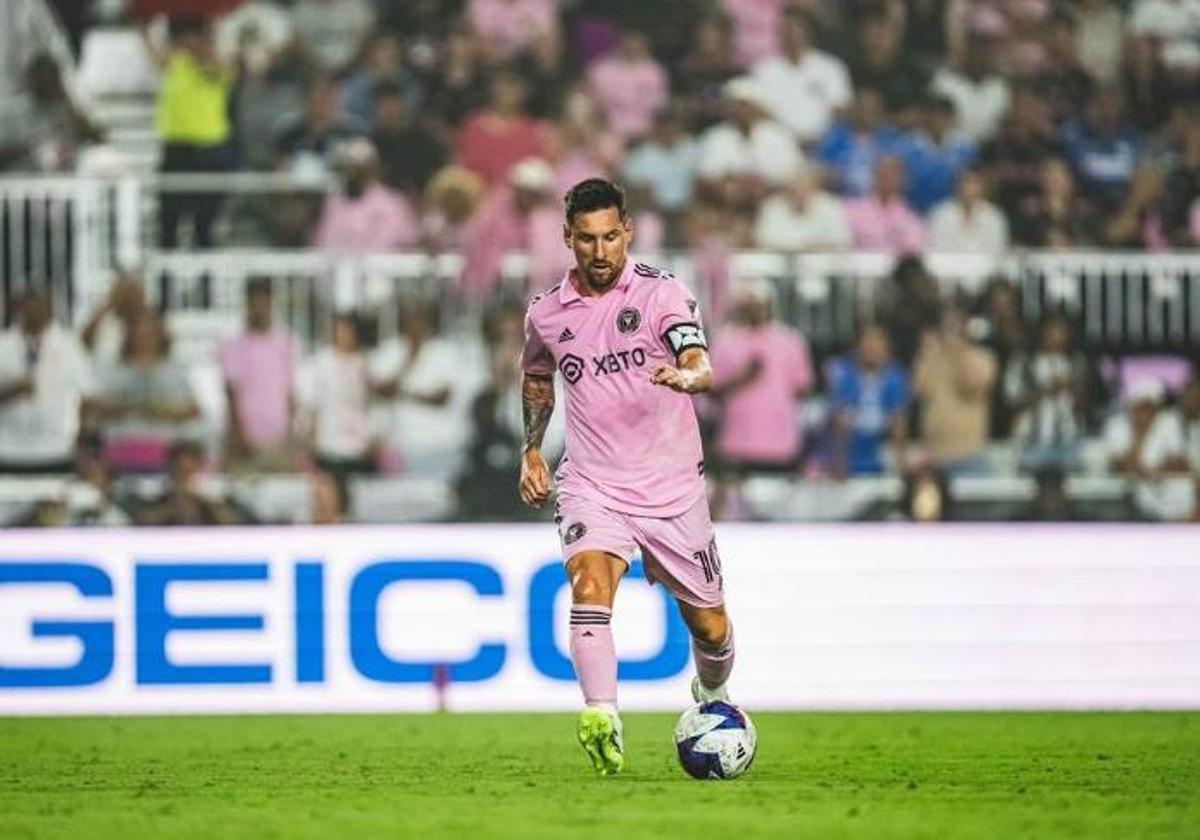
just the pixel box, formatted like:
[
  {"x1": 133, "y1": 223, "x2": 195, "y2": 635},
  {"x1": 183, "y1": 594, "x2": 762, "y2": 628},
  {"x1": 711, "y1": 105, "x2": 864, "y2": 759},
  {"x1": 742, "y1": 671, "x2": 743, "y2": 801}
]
[{"x1": 0, "y1": 259, "x2": 1200, "y2": 523}]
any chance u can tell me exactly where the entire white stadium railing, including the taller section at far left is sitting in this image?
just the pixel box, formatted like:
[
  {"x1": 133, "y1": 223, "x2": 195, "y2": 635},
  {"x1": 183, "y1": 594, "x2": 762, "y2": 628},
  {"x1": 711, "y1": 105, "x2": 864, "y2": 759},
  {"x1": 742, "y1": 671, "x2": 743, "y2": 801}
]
[{"x1": 0, "y1": 173, "x2": 1200, "y2": 352}]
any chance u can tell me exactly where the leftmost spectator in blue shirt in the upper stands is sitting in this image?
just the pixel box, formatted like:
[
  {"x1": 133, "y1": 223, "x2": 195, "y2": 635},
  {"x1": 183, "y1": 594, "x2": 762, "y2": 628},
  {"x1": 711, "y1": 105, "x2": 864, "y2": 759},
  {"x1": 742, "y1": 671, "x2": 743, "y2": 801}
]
[{"x1": 816, "y1": 88, "x2": 901, "y2": 198}]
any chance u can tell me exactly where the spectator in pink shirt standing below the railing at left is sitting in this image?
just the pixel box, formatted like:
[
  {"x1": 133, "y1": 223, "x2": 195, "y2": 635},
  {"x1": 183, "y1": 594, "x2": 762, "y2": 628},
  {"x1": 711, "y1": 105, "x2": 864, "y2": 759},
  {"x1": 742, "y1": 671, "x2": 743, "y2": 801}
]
[{"x1": 217, "y1": 277, "x2": 298, "y2": 472}]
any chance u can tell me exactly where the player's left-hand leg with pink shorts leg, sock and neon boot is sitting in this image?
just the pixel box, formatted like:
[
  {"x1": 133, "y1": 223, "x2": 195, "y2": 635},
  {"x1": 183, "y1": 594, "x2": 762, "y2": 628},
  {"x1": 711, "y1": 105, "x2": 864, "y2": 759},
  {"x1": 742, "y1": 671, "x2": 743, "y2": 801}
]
[{"x1": 556, "y1": 494, "x2": 636, "y2": 775}]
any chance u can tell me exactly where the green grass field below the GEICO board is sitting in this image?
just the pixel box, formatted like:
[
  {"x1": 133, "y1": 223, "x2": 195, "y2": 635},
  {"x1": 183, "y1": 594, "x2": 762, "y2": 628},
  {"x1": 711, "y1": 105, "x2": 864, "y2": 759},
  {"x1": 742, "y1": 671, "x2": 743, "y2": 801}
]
[{"x1": 0, "y1": 714, "x2": 1200, "y2": 840}]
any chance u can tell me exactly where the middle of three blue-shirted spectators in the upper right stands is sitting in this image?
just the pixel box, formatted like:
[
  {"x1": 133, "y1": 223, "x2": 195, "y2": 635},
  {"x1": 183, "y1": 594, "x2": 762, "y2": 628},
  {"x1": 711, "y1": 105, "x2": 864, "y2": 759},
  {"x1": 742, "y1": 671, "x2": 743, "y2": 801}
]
[{"x1": 902, "y1": 96, "x2": 978, "y2": 215}]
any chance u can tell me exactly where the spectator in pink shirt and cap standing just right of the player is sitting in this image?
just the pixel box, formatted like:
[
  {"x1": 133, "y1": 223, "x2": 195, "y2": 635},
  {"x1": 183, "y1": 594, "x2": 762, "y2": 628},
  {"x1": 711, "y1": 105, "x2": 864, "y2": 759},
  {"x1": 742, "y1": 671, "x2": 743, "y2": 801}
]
[{"x1": 712, "y1": 281, "x2": 814, "y2": 474}]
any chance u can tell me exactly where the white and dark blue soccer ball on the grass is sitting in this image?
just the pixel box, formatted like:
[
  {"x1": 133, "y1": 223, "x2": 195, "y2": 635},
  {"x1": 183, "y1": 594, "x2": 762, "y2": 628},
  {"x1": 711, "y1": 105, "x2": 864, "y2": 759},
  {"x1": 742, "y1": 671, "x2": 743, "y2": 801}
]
[{"x1": 674, "y1": 700, "x2": 758, "y2": 779}]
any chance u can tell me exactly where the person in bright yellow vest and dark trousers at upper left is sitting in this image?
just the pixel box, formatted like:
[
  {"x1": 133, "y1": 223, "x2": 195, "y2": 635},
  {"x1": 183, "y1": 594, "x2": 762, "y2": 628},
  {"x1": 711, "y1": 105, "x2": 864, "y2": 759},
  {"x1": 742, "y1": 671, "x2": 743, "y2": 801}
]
[{"x1": 155, "y1": 20, "x2": 235, "y2": 248}]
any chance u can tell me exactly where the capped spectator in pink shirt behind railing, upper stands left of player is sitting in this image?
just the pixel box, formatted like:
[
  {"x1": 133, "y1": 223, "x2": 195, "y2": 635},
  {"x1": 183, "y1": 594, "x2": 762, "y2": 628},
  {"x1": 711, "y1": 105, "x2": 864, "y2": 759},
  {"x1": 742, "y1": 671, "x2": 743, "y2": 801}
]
[{"x1": 313, "y1": 139, "x2": 420, "y2": 251}]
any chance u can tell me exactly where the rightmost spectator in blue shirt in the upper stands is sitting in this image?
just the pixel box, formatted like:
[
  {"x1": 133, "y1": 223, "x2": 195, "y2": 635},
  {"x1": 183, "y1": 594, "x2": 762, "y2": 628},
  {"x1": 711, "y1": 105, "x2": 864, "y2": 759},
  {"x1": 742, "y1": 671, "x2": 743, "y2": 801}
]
[{"x1": 1063, "y1": 88, "x2": 1142, "y2": 210}]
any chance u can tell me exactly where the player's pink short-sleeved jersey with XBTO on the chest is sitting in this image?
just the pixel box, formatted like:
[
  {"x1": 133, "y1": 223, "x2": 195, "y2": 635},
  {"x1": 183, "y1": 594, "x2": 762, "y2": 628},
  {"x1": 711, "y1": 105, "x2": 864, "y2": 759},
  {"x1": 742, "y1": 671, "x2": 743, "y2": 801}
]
[{"x1": 521, "y1": 259, "x2": 707, "y2": 518}]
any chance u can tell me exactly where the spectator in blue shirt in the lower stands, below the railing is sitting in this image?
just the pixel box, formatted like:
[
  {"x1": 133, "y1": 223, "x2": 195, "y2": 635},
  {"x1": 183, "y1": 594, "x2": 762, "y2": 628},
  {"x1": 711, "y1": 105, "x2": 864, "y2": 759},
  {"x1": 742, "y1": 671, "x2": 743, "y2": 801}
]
[{"x1": 827, "y1": 326, "x2": 910, "y2": 476}]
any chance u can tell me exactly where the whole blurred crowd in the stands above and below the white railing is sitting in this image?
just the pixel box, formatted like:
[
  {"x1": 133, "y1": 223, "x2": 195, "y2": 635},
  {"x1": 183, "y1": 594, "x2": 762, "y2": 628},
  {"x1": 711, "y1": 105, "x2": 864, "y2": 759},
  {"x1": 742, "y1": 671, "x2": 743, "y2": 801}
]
[{"x1": 0, "y1": 0, "x2": 1200, "y2": 524}]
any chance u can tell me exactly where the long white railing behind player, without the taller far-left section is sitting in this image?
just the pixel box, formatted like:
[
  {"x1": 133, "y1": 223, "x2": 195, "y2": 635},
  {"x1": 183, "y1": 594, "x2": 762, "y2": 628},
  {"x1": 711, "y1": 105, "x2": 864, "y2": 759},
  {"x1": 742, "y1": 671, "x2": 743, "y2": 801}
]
[{"x1": 136, "y1": 251, "x2": 1200, "y2": 353}]
